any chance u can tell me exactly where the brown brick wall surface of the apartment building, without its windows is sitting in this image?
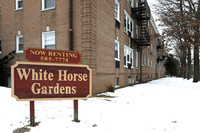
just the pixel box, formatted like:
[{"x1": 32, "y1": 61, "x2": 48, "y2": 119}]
[{"x1": 0, "y1": 0, "x2": 166, "y2": 94}]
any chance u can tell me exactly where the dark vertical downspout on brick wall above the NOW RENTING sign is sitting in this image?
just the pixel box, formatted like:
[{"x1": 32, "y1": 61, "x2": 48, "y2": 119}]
[{"x1": 69, "y1": 0, "x2": 74, "y2": 51}]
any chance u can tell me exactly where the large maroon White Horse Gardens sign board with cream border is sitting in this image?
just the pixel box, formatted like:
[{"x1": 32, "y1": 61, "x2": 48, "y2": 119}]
[{"x1": 11, "y1": 62, "x2": 92, "y2": 101}]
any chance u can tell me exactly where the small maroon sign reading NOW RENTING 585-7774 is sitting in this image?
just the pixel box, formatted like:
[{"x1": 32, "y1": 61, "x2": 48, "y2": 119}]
[{"x1": 25, "y1": 48, "x2": 81, "y2": 64}]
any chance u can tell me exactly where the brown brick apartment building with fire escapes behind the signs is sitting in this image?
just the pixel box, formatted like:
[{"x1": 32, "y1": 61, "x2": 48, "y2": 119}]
[{"x1": 0, "y1": 0, "x2": 164, "y2": 94}]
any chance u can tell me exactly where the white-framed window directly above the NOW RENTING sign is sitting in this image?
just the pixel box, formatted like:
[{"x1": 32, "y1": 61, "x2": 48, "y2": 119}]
[{"x1": 42, "y1": 31, "x2": 55, "y2": 49}]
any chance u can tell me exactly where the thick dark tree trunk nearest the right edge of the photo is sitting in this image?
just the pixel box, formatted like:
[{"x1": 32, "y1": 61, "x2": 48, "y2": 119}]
[{"x1": 193, "y1": 46, "x2": 199, "y2": 83}]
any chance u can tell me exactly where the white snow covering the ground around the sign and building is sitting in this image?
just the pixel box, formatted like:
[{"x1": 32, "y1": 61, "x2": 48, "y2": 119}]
[{"x1": 0, "y1": 78, "x2": 200, "y2": 133}]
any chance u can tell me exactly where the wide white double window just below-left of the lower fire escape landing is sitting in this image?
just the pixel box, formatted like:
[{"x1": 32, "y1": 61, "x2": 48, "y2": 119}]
[{"x1": 124, "y1": 45, "x2": 133, "y2": 68}]
